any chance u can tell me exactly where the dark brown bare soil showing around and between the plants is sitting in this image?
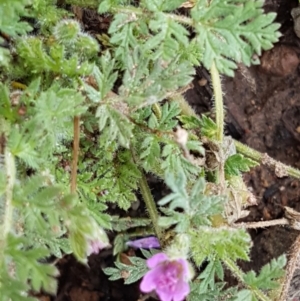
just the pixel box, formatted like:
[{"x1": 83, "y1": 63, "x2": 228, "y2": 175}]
[{"x1": 40, "y1": 0, "x2": 300, "y2": 301}]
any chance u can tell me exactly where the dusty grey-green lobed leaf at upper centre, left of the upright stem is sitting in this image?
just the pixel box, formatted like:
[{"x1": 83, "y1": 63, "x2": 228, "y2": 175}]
[{"x1": 119, "y1": 46, "x2": 195, "y2": 109}]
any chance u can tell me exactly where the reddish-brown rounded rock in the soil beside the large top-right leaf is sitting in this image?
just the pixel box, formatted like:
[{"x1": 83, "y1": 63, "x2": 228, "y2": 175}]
[{"x1": 260, "y1": 45, "x2": 300, "y2": 76}]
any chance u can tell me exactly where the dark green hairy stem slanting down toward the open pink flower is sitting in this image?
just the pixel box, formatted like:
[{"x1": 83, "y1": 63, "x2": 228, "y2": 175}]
[{"x1": 140, "y1": 171, "x2": 162, "y2": 241}]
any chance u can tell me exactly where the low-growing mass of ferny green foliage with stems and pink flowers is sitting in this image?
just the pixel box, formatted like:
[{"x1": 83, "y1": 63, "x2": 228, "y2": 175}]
[{"x1": 0, "y1": 0, "x2": 300, "y2": 301}]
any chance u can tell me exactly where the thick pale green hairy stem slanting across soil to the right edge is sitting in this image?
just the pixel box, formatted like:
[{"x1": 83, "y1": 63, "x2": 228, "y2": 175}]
[{"x1": 234, "y1": 141, "x2": 300, "y2": 179}]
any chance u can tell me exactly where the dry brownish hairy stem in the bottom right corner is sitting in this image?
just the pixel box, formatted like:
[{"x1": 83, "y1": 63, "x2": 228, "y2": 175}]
[{"x1": 277, "y1": 235, "x2": 300, "y2": 301}]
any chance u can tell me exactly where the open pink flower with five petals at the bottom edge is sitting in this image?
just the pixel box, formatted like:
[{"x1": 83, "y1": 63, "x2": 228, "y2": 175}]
[{"x1": 140, "y1": 253, "x2": 190, "y2": 301}]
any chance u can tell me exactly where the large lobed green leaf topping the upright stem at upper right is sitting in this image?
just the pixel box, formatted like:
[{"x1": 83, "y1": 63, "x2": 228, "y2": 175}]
[{"x1": 191, "y1": 0, "x2": 280, "y2": 76}]
